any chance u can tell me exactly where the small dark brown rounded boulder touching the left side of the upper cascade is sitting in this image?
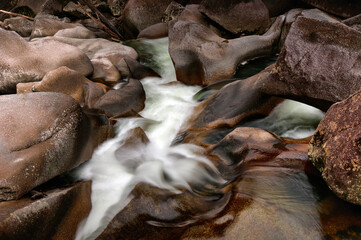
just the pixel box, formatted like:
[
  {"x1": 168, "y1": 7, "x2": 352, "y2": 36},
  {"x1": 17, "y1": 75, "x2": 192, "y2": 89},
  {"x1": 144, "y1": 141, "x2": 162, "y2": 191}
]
[{"x1": 93, "y1": 79, "x2": 145, "y2": 118}]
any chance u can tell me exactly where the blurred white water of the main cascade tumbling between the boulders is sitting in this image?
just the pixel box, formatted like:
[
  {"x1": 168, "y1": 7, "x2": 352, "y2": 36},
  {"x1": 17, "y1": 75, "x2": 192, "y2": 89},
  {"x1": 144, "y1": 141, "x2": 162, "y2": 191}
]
[{"x1": 76, "y1": 39, "x2": 221, "y2": 240}]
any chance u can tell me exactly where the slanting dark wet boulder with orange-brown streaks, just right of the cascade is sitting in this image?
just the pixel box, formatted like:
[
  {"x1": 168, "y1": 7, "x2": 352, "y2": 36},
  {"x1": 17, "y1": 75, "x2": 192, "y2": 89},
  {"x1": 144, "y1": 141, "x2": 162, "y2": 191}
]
[{"x1": 178, "y1": 69, "x2": 282, "y2": 146}]
